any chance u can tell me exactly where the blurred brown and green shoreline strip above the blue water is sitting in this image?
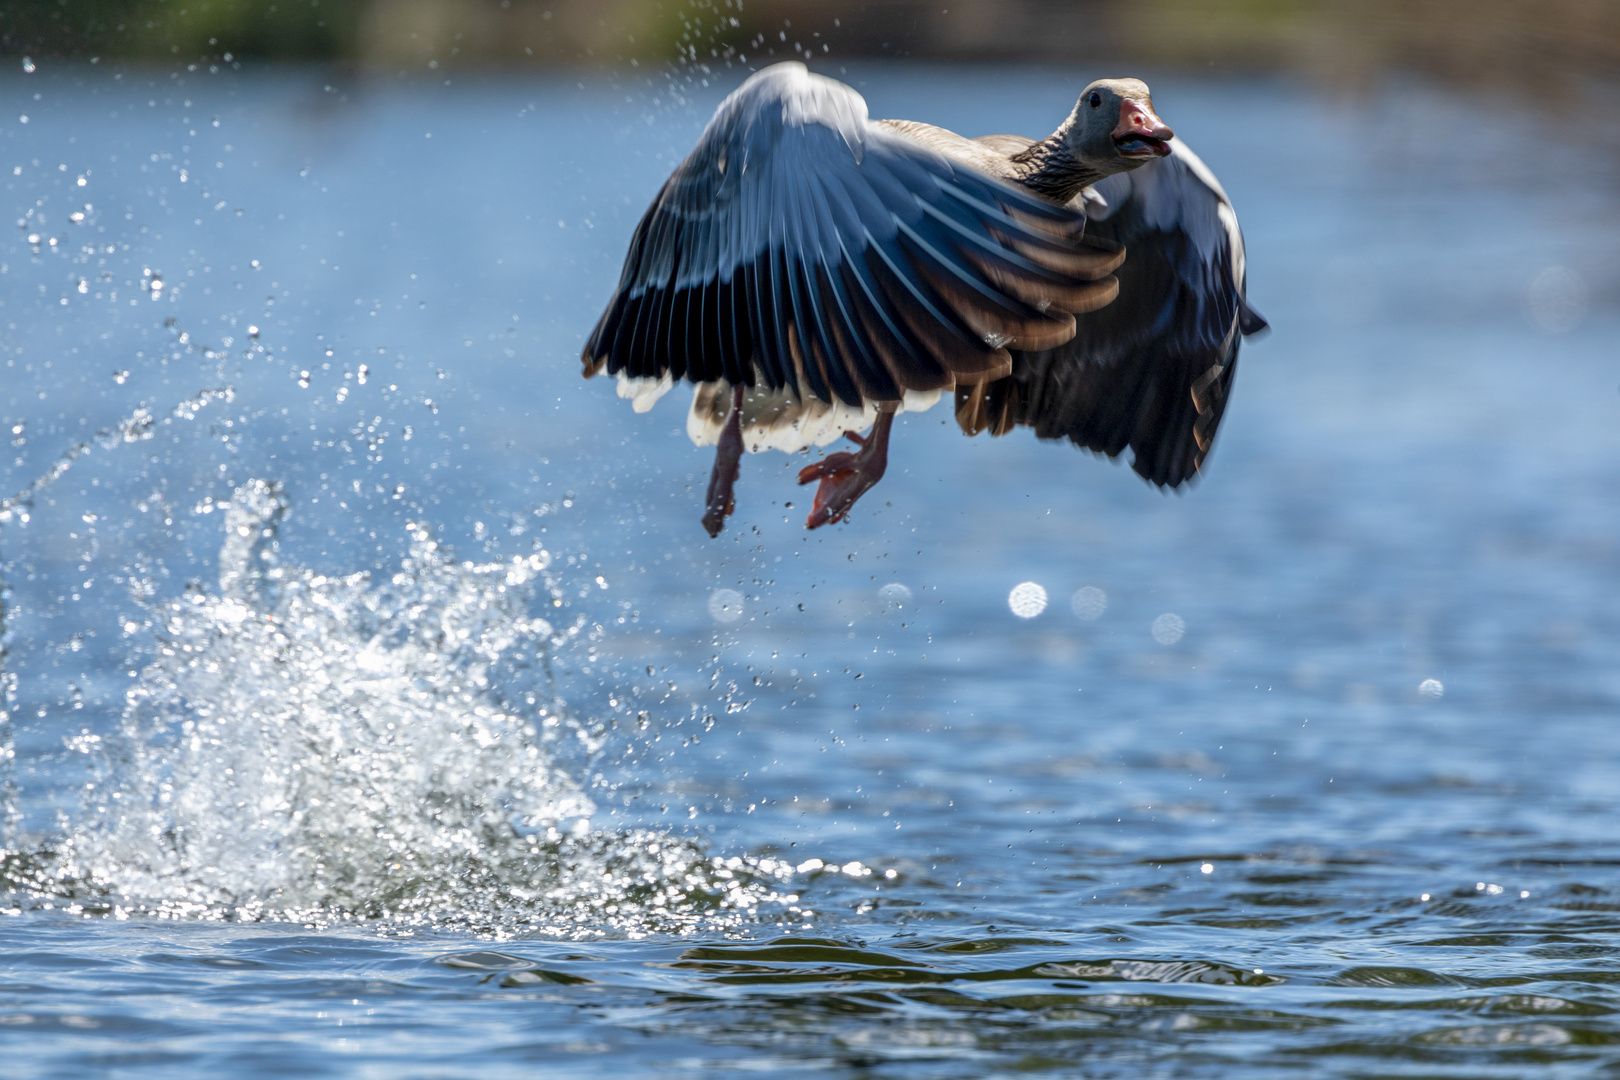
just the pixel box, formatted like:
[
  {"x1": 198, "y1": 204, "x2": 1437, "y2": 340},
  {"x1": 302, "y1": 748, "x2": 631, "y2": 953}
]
[{"x1": 0, "y1": 0, "x2": 1620, "y2": 90}]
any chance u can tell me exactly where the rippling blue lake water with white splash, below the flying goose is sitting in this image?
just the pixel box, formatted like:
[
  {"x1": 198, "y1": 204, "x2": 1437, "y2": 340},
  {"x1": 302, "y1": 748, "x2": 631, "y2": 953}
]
[{"x1": 0, "y1": 62, "x2": 1620, "y2": 1077}]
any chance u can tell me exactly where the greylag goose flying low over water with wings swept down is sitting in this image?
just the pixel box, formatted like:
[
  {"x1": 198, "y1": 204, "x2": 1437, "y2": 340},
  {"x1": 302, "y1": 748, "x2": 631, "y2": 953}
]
[{"x1": 582, "y1": 62, "x2": 1265, "y2": 538}]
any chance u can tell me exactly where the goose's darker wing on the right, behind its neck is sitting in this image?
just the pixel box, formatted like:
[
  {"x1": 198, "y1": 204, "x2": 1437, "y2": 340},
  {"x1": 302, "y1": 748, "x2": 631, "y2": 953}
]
[{"x1": 957, "y1": 141, "x2": 1265, "y2": 487}]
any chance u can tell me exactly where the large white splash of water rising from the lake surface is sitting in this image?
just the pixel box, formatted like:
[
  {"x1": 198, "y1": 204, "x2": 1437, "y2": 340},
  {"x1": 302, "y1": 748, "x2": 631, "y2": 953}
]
[{"x1": 0, "y1": 481, "x2": 797, "y2": 933}]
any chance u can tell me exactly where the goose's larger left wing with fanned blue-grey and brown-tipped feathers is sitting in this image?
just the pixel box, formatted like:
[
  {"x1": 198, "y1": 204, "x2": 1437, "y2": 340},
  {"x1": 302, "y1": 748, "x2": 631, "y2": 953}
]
[{"x1": 585, "y1": 63, "x2": 1119, "y2": 405}]
